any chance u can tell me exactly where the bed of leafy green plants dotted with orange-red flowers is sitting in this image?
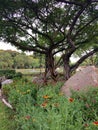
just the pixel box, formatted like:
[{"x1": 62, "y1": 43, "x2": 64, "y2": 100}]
[{"x1": 4, "y1": 77, "x2": 98, "y2": 130}]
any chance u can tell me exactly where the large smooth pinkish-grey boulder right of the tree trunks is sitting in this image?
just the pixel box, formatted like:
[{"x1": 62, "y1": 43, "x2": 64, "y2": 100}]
[{"x1": 61, "y1": 66, "x2": 98, "y2": 96}]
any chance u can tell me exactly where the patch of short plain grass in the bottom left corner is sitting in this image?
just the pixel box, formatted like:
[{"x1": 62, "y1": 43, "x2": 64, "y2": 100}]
[{"x1": 0, "y1": 101, "x2": 15, "y2": 130}]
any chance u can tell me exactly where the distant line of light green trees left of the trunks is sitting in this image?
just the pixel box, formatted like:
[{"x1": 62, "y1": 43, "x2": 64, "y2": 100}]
[{"x1": 0, "y1": 50, "x2": 44, "y2": 69}]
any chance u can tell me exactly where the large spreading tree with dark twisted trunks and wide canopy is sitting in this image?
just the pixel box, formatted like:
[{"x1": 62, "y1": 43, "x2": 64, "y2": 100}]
[{"x1": 0, "y1": 0, "x2": 98, "y2": 80}]
